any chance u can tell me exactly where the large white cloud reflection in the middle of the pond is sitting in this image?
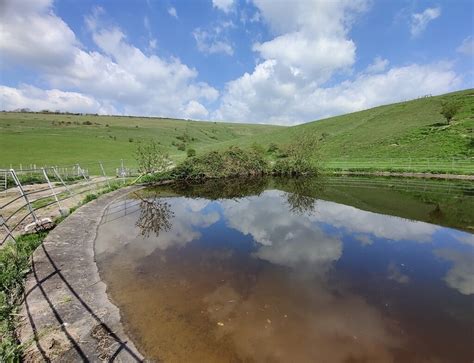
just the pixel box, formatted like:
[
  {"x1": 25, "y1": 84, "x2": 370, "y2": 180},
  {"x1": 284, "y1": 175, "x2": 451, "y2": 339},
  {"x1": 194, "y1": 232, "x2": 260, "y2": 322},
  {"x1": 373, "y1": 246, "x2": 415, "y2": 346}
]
[{"x1": 221, "y1": 190, "x2": 342, "y2": 275}]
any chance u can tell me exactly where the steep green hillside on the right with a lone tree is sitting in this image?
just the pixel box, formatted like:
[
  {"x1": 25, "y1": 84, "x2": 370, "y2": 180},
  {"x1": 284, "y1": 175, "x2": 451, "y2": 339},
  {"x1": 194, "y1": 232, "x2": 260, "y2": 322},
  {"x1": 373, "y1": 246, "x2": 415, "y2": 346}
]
[{"x1": 204, "y1": 89, "x2": 474, "y2": 160}]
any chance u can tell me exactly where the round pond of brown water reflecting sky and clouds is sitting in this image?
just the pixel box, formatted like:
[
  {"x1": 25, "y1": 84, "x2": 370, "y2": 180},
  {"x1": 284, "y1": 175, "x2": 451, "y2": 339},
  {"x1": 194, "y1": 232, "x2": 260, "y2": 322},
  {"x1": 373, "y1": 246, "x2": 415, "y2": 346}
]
[{"x1": 96, "y1": 177, "x2": 474, "y2": 362}]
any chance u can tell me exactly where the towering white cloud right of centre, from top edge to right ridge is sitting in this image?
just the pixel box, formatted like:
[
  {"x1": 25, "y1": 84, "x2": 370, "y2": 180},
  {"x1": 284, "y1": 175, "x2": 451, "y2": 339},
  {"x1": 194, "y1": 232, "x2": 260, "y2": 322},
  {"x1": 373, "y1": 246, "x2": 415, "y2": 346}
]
[{"x1": 213, "y1": 0, "x2": 461, "y2": 125}]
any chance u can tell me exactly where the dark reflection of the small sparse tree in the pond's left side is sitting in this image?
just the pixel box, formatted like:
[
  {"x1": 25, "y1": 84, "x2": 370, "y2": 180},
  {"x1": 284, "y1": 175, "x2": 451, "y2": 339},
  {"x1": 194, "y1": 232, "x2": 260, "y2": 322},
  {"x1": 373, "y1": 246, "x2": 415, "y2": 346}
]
[{"x1": 136, "y1": 197, "x2": 174, "y2": 238}]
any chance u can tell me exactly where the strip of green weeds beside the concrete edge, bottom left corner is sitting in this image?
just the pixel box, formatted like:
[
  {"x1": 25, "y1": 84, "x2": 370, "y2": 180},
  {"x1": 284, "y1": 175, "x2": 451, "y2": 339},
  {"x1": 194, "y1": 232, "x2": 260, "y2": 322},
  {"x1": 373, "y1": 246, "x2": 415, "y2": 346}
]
[{"x1": 0, "y1": 232, "x2": 46, "y2": 362}]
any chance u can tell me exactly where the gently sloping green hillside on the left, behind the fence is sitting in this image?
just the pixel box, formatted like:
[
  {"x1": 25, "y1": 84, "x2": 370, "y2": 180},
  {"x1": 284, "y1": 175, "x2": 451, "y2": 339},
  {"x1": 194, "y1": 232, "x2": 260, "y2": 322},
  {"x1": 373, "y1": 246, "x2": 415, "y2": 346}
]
[{"x1": 0, "y1": 113, "x2": 280, "y2": 167}]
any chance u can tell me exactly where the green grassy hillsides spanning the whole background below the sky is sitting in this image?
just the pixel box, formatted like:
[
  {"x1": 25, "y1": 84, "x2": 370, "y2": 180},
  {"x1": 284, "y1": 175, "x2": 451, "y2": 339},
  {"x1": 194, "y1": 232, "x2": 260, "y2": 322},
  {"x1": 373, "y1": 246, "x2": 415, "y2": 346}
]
[{"x1": 0, "y1": 89, "x2": 474, "y2": 174}]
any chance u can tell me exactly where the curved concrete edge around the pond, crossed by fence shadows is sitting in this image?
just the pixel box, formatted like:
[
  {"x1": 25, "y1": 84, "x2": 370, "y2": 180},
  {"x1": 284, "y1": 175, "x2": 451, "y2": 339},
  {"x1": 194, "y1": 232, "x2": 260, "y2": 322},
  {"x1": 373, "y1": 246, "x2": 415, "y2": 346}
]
[{"x1": 19, "y1": 188, "x2": 143, "y2": 362}]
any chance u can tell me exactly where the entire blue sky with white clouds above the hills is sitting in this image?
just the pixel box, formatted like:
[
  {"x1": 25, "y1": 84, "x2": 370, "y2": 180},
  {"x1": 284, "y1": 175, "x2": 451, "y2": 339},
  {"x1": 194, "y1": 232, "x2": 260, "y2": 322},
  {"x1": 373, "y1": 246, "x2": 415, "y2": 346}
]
[{"x1": 0, "y1": 0, "x2": 474, "y2": 125}]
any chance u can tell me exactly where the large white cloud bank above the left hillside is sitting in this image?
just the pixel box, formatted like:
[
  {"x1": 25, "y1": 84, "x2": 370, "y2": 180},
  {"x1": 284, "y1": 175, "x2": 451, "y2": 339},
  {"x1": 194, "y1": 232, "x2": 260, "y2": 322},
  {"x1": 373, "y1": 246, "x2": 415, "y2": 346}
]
[{"x1": 0, "y1": 0, "x2": 218, "y2": 117}]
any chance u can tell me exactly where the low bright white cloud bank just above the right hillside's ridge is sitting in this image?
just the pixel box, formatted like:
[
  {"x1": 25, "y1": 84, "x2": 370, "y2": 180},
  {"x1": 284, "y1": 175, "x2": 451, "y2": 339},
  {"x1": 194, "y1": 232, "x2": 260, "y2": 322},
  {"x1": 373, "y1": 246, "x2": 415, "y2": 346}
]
[{"x1": 217, "y1": 60, "x2": 461, "y2": 125}]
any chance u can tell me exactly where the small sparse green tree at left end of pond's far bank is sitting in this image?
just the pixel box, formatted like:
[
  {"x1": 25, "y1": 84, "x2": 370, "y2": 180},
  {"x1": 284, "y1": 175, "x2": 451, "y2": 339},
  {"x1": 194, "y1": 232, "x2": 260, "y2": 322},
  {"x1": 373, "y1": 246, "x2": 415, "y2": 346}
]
[{"x1": 135, "y1": 139, "x2": 170, "y2": 174}]
